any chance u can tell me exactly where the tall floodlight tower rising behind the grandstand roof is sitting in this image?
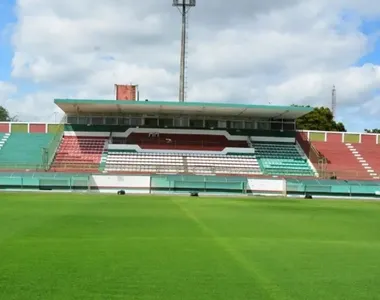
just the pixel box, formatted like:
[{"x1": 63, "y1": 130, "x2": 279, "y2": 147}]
[{"x1": 173, "y1": 0, "x2": 196, "y2": 102}]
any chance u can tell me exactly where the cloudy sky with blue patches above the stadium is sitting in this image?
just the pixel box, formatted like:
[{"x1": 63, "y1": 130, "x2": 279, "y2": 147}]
[{"x1": 0, "y1": 0, "x2": 380, "y2": 131}]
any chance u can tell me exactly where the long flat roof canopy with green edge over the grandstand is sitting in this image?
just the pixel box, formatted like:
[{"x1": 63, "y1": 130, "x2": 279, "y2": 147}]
[{"x1": 54, "y1": 99, "x2": 313, "y2": 119}]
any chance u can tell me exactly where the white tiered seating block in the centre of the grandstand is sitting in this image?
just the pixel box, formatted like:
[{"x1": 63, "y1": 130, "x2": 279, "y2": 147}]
[{"x1": 105, "y1": 151, "x2": 261, "y2": 175}]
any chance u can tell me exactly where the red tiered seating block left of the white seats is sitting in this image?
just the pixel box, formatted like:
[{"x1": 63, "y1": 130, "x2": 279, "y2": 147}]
[{"x1": 52, "y1": 136, "x2": 106, "y2": 171}]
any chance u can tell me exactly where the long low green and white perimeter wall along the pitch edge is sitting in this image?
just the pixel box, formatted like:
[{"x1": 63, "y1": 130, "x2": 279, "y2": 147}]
[{"x1": 0, "y1": 172, "x2": 380, "y2": 198}]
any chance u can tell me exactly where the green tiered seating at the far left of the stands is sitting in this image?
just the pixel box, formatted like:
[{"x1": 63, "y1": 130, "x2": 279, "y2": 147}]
[{"x1": 0, "y1": 133, "x2": 54, "y2": 169}]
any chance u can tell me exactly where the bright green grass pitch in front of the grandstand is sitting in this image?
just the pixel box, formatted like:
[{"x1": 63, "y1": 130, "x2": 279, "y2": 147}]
[{"x1": 0, "y1": 193, "x2": 380, "y2": 300}]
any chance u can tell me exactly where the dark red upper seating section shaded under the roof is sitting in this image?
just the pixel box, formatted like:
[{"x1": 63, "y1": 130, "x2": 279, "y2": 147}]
[{"x1": 113, "y1": 133, "x2": 248, "y2": 151}]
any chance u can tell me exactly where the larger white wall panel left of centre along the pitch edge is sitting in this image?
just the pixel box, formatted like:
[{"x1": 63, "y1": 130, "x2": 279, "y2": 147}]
[{"x1": 90, "y1": 175, "x2": 150, "y2": 194}]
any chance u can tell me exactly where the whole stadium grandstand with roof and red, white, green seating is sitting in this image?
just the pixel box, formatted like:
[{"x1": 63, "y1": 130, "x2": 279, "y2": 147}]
[{"x1": 0, "y1": 91, "x2": 380, "y2": 180}]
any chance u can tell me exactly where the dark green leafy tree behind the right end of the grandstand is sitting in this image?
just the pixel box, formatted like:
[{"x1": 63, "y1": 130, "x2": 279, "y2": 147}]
[{"x1": 294, "y1": 105, "x2": 347, "y2": 132}]
